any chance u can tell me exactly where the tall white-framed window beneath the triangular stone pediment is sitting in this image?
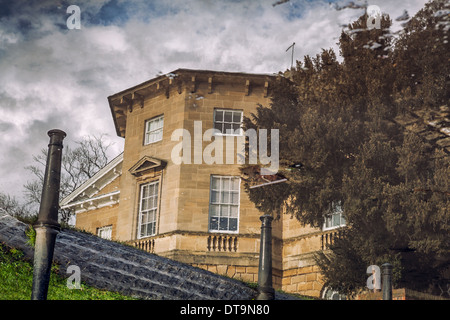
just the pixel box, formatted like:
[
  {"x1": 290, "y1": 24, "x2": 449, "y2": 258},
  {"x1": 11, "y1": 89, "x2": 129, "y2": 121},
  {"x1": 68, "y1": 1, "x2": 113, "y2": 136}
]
[{"x1": 137, "y1": 180, "x2": 159, "y2": 239}]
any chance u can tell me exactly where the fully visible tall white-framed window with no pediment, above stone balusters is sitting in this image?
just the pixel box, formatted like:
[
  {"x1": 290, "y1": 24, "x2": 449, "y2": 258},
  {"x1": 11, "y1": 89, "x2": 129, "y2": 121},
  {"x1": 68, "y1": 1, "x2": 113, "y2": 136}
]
[{"x1": 208, "y1": 175, "x2": 241, "y2": 233}]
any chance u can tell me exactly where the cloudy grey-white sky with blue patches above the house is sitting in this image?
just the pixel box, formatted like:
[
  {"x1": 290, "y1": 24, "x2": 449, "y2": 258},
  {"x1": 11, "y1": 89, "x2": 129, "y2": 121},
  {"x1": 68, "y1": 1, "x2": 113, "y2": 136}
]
[{"x1": 0, "y1": 0, "x2": 426, "y2": 199}]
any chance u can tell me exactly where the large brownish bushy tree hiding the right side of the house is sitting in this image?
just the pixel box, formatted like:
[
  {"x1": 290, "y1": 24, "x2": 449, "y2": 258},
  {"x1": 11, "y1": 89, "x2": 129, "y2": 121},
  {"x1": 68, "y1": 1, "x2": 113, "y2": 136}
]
[{"x1": 242, "y1": 0, "x2": 450, "y2": 295}]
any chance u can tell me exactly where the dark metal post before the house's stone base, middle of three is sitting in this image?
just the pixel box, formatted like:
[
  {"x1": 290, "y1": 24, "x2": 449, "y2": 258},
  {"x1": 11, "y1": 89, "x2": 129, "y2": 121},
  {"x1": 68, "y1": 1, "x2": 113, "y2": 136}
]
[{"x1": 256, "y1": 214, "x2": 275, "y2": 300}]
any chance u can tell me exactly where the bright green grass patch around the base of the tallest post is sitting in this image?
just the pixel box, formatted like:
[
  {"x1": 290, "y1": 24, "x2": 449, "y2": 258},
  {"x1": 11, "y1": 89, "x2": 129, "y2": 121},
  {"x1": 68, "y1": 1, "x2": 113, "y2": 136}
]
[{"x1": 0, "y1": 243, "x2": 136, "y2": 300}]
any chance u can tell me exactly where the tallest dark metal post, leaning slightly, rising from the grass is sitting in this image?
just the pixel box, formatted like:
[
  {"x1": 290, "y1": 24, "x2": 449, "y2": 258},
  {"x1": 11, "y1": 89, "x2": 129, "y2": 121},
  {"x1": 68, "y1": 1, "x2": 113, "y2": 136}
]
[{"x1": 31, "y1": 129, "x2": 66, "y2": 300}]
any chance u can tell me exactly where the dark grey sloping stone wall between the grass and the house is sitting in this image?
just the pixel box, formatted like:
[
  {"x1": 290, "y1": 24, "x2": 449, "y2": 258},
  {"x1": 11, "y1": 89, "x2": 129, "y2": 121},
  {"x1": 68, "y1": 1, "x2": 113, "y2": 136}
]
[{"x1": 0, "y1": 211, "x2": 296, "y2": 300}]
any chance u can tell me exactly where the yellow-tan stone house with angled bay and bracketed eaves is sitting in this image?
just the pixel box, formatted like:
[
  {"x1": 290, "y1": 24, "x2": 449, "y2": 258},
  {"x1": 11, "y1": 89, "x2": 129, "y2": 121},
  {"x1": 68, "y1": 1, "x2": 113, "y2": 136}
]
[{"x1": 60, "y1": 69, "x2": 345, "y2": 297}]
